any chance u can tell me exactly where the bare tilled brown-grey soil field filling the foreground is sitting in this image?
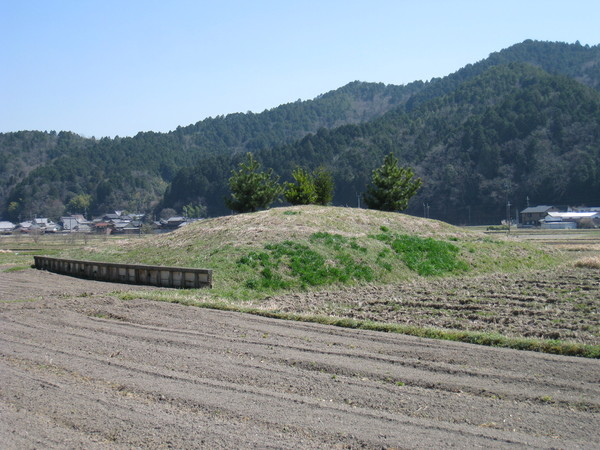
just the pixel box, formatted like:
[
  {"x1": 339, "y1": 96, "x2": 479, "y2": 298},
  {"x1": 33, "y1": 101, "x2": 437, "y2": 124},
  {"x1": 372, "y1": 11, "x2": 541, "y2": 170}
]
[{"x1": 0, "y1": 269, "x2": 600, "y2": 449}]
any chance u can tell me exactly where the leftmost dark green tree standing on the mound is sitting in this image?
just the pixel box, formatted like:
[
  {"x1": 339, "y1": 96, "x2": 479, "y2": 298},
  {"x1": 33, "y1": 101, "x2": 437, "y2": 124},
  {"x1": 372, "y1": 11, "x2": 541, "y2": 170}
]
[{"x1": 225, "y1": 153, "x2": 282, "y2": 213}]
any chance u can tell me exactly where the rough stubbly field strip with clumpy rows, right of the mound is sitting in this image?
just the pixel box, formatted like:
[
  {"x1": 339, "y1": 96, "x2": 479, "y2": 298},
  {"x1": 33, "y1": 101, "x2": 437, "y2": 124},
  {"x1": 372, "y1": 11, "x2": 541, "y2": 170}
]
[{"x1": 262, "y1": 265, "x2": 600, "y2": 344}]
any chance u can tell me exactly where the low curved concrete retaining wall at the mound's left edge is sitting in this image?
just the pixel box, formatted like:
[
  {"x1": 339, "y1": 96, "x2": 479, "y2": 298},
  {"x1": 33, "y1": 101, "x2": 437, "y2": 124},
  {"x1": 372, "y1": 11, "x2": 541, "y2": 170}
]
[{"x1": 34, "y1": 256, "x2": 212, "y2": 289}]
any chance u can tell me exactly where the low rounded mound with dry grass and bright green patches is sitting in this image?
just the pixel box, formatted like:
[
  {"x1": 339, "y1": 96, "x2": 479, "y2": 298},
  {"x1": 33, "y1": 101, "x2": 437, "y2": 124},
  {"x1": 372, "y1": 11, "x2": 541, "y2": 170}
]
[{"x1": 63, "y1": 206, "x2": 556, "y2": 300}]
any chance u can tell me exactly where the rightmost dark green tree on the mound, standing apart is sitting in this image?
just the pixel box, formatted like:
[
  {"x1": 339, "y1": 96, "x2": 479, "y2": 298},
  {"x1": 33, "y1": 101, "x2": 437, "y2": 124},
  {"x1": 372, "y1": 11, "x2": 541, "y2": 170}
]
[{"x1": 363, "y1": 153, "x2": 423, "y2": 211}]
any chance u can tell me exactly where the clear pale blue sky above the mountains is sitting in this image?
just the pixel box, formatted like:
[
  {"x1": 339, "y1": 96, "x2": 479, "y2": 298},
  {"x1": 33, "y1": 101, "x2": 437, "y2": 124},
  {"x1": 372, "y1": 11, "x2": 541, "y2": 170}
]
[{"x1": 0, "y1": 0, "x2": 600, "y2": 138}]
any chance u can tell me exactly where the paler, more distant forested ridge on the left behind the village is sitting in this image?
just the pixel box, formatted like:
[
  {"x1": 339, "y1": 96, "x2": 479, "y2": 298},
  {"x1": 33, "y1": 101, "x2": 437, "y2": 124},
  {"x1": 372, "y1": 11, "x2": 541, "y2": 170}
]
[{"x1": 0, "y1": 82, "x2": 423, "y2": 220}]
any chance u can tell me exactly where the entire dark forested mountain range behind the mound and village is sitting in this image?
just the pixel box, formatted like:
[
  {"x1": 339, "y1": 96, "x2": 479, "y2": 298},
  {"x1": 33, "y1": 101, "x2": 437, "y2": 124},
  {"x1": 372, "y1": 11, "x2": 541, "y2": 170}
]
[{"x1": 0, "y1": 41, "x2": 600, "y2": 223}]
